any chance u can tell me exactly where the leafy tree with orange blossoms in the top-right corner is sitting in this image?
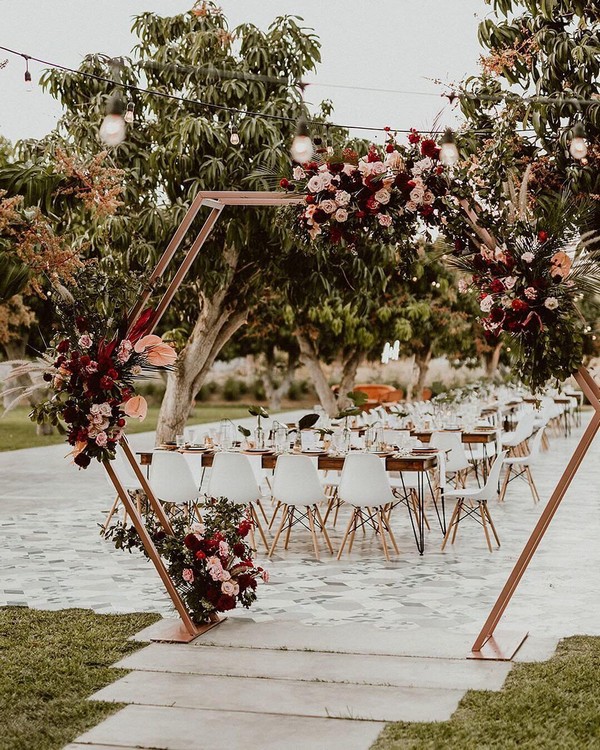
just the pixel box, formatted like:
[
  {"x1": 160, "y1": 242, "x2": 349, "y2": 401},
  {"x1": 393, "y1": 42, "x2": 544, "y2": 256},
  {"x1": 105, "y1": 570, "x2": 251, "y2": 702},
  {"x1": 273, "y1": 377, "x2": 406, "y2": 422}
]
[{"x1": 460, "y1": 0, "x2": 600, "y2": 226}]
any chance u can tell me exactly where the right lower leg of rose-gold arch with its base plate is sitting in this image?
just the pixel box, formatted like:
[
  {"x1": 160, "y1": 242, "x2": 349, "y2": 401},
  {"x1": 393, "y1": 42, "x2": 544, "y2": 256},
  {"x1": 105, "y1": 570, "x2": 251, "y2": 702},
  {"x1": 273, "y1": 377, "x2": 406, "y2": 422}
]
[{"x1": 470, "y1": 367, "x2": 600, "y2": 660}]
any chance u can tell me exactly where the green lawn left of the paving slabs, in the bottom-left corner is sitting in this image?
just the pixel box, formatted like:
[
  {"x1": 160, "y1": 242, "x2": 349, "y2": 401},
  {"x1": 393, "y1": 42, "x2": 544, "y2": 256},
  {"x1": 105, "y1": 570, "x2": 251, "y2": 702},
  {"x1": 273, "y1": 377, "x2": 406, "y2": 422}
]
[{"x1": 0, "y1": 607, "x2": 159, "y2": 750}]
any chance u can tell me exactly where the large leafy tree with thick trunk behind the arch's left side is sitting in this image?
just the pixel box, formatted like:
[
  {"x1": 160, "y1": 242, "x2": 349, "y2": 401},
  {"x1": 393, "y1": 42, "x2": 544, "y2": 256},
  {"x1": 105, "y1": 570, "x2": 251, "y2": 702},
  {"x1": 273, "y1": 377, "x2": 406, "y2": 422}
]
[{"x1": 38, "y1": 2, "x2": 319, "y2": 441}]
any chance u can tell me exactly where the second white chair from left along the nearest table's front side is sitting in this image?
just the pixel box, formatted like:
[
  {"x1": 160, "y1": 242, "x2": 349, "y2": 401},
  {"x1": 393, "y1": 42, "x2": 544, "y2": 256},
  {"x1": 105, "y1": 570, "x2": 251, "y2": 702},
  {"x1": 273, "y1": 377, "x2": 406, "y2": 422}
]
[{"x1": 206, "y1": 453, "x2": 269, "y2": 551}]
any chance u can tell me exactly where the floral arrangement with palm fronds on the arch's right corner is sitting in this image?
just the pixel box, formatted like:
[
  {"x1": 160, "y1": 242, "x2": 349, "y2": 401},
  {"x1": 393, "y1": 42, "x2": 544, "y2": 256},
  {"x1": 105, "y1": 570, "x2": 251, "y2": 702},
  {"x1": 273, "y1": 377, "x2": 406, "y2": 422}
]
[{"x1": 453, "y1": 204, "x2": 600, "y2": 391}]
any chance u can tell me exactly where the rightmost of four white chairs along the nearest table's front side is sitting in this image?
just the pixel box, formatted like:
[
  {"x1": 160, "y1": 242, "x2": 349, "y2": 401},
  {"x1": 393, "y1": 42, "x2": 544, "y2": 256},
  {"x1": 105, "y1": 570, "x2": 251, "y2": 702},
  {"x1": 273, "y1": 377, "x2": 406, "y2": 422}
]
[{"x1": 337, "y1": 453, "x2": 398, "y2": 560}]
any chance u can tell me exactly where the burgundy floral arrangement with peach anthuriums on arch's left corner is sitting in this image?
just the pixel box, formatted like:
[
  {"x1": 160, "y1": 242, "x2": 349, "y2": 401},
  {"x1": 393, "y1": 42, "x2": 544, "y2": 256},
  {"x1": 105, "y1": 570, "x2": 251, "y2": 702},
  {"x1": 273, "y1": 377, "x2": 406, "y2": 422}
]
[{"x1": 28, "y1": 269, "x2": 177, "y2": 469}]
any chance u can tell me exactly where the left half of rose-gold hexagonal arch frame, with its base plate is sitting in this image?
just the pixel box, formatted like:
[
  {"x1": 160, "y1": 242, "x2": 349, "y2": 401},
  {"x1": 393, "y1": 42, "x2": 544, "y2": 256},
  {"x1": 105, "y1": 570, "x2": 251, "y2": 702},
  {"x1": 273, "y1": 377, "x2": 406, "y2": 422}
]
[{"x1": 104, "y1": 191, "x2": 304, "y2": 643}]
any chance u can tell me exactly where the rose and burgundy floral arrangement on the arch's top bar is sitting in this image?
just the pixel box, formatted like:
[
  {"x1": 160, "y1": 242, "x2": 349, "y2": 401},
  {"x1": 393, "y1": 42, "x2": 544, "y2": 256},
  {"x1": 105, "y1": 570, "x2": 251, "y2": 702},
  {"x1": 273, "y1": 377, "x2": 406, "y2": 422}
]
[{"x1": 280, "y1": 128, "x2": 448, "y2": 254}]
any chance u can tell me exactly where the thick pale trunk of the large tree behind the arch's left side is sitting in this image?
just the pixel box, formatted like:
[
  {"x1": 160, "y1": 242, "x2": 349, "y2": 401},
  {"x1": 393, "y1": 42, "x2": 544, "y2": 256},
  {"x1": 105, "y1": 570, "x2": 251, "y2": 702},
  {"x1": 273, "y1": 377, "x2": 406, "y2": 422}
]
[{"x1": 156, "y1": 250, "x2": 248, "y2": 444}]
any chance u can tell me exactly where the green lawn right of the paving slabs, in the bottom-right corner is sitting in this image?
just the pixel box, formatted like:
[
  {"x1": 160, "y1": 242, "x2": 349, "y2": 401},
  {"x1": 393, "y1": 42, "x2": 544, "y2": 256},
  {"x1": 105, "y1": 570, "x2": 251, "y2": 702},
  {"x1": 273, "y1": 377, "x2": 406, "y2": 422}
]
[{"x1": 371, "y1": 636, "x2": 600, "y2": 750}]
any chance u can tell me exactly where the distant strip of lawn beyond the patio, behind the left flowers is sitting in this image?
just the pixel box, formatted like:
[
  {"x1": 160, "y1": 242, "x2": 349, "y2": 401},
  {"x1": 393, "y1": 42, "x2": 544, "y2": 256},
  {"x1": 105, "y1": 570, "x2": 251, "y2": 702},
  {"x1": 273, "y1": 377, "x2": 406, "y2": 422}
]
[{"x1": 0, "y1": 403, "x2": 264, "y2": 451}]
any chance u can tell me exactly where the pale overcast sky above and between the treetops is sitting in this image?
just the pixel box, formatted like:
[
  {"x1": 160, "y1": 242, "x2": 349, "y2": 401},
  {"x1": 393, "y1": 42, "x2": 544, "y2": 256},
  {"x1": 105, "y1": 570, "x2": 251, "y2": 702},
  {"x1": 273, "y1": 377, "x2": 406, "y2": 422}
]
[{"x1": 0, "y1": 0, "x2": 489, "y2": 141}]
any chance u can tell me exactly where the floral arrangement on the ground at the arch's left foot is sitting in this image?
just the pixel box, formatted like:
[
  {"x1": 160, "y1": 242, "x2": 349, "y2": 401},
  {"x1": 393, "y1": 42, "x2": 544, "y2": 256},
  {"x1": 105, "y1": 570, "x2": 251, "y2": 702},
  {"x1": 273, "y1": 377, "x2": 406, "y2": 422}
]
[{"x1": 105, "y1": 497, "x2": 269, "y2": 623}]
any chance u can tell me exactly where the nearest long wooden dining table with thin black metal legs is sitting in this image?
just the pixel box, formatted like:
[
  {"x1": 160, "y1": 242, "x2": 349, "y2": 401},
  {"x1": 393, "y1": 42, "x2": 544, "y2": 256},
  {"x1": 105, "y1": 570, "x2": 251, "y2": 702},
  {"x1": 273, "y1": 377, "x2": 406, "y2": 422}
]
[{"x1": 137, "y1": 448, "x2": 446, "y2": 555}]
